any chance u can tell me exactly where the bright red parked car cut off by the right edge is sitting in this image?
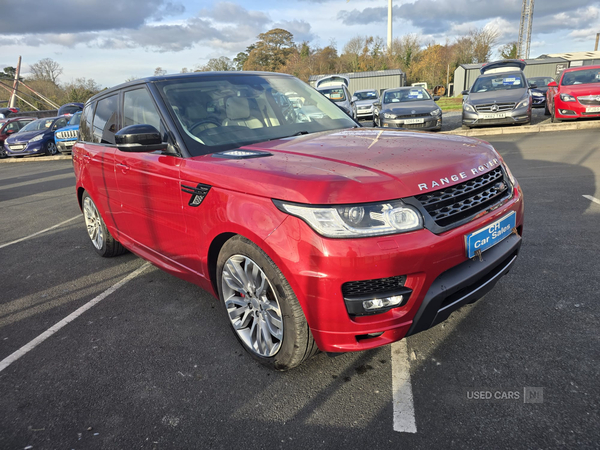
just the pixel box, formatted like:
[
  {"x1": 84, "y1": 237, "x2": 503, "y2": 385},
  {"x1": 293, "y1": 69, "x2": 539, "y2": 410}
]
[{"x1": 546, "y1": 66, "x2": 600, "y2": 122}]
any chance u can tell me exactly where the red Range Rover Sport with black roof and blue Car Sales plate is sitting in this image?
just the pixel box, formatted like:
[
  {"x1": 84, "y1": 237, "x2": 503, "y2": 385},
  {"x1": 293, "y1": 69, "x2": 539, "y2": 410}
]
[{"x1": 73, "y1": 72, "x2": 523, "y2": 370}]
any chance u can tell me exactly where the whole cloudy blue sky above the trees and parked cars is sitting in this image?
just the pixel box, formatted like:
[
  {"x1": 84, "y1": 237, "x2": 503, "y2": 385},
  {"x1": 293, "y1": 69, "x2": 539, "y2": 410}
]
[{"x1": 0, "y1": 0, "x2": 600, "y2": 87}]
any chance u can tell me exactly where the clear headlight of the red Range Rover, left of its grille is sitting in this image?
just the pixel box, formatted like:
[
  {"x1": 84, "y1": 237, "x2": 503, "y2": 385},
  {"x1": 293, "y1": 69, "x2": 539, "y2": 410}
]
[{"x1": 273, "y1": 200, "x2": 423, "y2": 238}]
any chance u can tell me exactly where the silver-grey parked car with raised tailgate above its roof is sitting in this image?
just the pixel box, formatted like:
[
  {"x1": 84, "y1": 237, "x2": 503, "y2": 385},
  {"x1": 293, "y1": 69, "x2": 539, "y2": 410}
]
[{"x1": 462, "y1": 60, "x2": 536, "y2": 128}]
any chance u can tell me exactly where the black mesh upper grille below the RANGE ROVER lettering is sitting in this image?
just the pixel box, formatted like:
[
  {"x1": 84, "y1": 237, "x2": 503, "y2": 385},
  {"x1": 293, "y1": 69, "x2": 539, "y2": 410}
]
[{"x1": 415, "y1": 167, "x2": 510, "y2": 227}]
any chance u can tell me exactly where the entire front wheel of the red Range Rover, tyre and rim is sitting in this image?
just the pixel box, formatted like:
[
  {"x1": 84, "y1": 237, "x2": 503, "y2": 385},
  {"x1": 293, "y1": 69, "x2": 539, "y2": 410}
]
[{"x1": 217, "y1": 235, "x2": 318, "y2": 371}]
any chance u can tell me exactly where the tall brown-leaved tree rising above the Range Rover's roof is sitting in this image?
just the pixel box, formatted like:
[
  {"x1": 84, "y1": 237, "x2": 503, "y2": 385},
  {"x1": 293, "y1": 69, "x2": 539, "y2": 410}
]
[{"x1": 244, "y1": 28, "x2": 296, "y2": 72}]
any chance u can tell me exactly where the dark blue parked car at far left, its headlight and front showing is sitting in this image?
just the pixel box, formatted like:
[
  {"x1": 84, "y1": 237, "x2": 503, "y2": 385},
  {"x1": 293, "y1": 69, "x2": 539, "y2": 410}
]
[{"x1": 4, "y1": 117, "x2": 68, "y2": 156}]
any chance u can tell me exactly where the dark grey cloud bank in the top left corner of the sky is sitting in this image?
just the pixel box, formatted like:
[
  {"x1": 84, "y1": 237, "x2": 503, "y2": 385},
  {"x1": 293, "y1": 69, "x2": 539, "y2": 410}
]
[{"x1": 0, "y1": 0, "x2": 185, "y2": 35}]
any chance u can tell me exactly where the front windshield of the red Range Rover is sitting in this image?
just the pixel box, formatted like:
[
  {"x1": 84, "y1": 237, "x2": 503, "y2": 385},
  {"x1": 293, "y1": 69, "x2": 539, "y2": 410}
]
[{"x1": 157, "y1": 75, "x2": 356, "y2": 155}]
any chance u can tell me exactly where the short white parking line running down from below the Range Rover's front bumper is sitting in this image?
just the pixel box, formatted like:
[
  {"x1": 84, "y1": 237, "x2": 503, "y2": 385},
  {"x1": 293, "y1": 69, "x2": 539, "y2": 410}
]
[{"x1": 391, "y1": 339, "x2": 417, "y2": 433}]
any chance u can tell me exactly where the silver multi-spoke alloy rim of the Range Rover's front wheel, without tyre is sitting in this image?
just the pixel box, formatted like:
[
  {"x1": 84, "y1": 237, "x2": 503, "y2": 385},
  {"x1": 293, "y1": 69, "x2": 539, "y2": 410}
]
[{"x1": 221, "y1": 255, "x2": 283, "y2": 358}]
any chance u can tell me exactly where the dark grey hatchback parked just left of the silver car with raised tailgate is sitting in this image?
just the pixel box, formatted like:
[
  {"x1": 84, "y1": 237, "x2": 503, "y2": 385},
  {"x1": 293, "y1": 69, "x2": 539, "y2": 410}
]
[{"x1": 373, "y1": 86, "x2": 442, "y2": 131}]
